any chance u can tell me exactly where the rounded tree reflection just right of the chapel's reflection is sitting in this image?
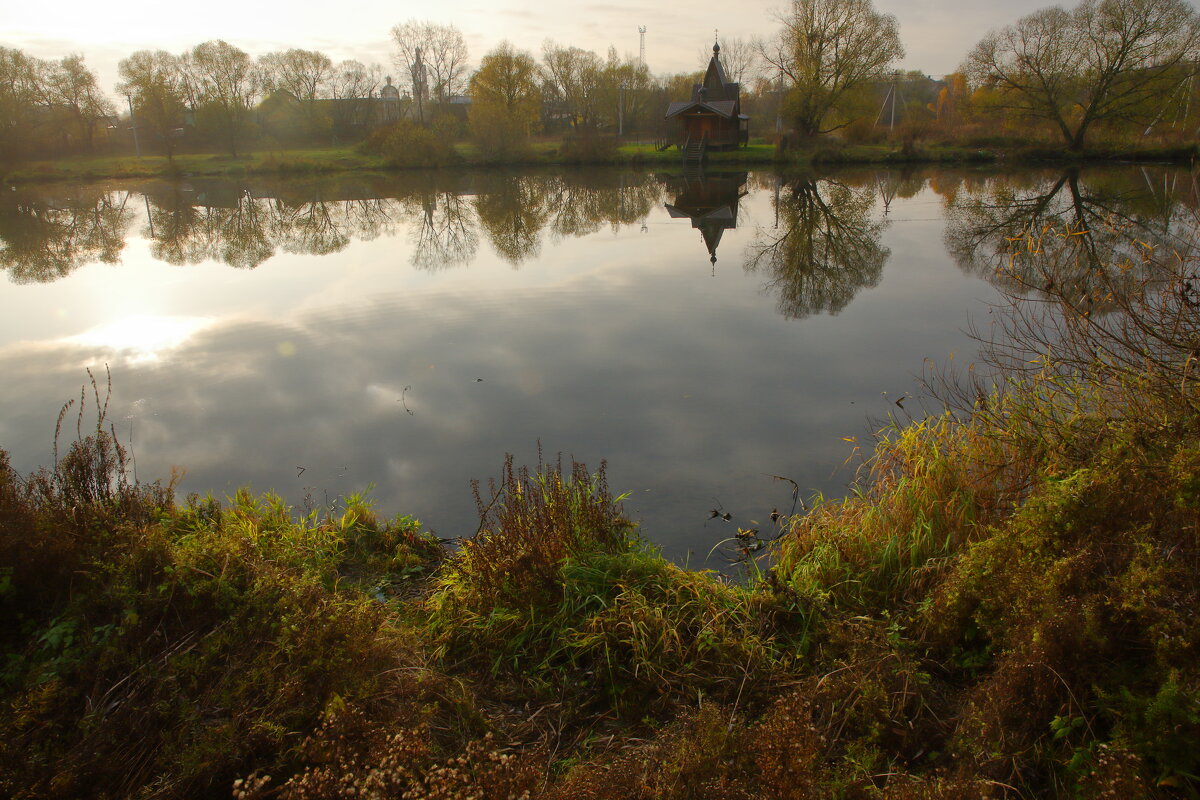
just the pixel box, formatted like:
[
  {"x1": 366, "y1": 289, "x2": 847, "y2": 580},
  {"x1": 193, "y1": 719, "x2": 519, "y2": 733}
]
[{"x1": 745, "y1": 176, "x2": 890, "y2": 319}]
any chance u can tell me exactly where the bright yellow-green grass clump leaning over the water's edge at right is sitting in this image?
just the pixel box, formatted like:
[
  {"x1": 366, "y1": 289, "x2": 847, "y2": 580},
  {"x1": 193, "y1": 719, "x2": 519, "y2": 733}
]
[{"x1": 774, "y1": 401, "x2": 1032, "y2": 608}]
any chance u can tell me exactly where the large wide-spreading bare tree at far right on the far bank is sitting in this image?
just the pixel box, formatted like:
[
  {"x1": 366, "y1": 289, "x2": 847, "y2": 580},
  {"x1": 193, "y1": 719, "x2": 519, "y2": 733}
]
[{"x1": 965, "y1": 0, "x2": 1200, "y2": 150}]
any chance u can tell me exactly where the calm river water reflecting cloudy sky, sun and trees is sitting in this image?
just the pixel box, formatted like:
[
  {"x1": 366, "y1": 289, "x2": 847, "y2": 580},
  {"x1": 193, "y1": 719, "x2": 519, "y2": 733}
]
[{"x1": 0, "y1": 167, "x2": 1196, "y2": 566}]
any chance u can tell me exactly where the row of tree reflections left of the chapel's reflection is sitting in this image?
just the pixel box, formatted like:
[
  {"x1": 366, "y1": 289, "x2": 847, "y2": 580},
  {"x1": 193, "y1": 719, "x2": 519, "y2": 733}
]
[{"x1": 0, "y1": 170, "x2": 664, "y2": 282}]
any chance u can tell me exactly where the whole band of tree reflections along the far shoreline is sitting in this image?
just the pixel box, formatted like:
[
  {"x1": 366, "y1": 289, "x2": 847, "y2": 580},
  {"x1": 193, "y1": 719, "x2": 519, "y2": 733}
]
[{"x1": 14, "y1": 167, "x2": 1198, "y2": 309}]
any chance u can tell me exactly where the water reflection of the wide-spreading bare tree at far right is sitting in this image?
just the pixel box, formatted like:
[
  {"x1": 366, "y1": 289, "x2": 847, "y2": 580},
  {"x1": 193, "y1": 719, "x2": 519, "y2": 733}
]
[{"x1": 938, "y1": 167, "x2": 1196, "y2": 312}]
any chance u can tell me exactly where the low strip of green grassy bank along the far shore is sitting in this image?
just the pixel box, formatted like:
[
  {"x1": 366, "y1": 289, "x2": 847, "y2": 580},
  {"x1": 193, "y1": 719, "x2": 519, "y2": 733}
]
[{"x1": 4, "y1": 140, "x2": 1196, "y2": 184}]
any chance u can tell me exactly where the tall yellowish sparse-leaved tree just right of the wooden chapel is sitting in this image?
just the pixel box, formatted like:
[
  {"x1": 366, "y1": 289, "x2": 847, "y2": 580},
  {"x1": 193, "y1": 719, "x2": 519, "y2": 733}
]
[{"x1": 758, "y1": 0, "x2": 904, "y2": 136}]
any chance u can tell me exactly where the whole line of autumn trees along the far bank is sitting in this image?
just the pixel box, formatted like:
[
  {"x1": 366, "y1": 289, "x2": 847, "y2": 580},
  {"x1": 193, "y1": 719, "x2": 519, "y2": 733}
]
[{"x1": 0, "y1": 0, "x2": 1200, "y2": 172}]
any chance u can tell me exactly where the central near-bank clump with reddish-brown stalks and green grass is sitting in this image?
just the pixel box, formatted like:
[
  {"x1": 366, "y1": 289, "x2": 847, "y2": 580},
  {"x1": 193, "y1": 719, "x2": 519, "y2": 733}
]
[{"x1": 428, "y1": 458, "x2": 781, "y2": 711}]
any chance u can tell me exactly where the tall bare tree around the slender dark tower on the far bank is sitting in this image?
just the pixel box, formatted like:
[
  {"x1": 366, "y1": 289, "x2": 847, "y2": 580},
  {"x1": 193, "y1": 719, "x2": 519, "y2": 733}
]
[{"x1": 391, "y1": 19, "x2": 468, "y2": 121}]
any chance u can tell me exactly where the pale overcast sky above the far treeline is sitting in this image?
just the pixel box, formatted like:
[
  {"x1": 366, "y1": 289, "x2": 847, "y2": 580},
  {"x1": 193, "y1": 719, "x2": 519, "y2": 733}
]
[{"x1": 7, "y1": 0, "x2": 1052, "y2": 101}]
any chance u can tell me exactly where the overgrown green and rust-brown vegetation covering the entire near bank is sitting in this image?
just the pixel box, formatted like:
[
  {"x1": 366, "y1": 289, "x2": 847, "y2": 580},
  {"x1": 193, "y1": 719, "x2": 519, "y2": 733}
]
[{"x1": 0, "y1": 224, "x2": 1200, "y2": 799}]
